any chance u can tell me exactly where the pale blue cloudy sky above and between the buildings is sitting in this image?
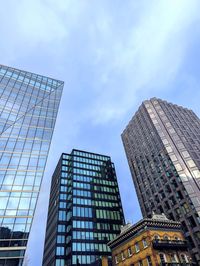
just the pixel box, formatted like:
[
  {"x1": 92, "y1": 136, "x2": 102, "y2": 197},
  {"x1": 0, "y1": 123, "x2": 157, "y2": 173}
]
[{"x1": 0, "y1": 0, "x2": 200, "y2": 266}]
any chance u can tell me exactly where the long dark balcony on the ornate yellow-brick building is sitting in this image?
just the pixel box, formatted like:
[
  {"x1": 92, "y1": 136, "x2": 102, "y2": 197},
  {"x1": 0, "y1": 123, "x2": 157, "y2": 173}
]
[{"x1": 153, "y1": 239, "x2": 188, "y2": 250}]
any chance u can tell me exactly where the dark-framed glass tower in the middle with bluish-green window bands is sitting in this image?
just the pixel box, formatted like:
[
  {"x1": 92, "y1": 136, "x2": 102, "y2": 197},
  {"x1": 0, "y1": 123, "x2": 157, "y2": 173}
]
[{"x1": 43, "y1": 150, "x2": 124, "y2": 266}]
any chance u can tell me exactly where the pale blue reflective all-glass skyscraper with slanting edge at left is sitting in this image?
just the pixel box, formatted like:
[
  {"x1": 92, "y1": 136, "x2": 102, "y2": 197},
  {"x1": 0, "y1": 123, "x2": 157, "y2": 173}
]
[{"x1": 0, "y1": 65, "x2": 64, "y2": 266}]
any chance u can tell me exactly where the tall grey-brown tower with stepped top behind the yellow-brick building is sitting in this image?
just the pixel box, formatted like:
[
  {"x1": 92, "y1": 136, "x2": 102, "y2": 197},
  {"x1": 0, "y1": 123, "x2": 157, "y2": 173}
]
[{"x1": 122, "y1": 98, "x2": 200, "y2": 265}]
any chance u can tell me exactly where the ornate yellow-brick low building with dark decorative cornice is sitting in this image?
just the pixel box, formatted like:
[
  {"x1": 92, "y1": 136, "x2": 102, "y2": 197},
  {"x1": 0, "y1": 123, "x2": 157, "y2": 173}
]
[{"x1": 108, "y1": 214, "x2": 195, "y2": 266}]
